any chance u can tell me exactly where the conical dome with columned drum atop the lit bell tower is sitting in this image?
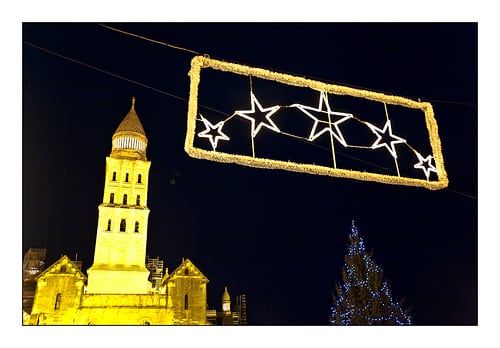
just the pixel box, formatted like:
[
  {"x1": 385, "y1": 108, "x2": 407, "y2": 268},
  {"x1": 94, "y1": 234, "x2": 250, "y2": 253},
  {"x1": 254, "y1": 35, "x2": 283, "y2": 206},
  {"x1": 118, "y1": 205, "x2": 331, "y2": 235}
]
[{"x1": 111, "y1": 97, "x2": 148, "y2": 160}]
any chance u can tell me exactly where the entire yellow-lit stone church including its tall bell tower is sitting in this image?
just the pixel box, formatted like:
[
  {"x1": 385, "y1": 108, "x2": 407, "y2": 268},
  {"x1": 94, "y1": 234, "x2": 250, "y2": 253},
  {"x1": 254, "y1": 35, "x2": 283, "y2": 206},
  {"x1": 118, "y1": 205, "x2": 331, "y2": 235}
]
[{"x1": 23, "y1": 98, "x2": 246, "y2": 325}]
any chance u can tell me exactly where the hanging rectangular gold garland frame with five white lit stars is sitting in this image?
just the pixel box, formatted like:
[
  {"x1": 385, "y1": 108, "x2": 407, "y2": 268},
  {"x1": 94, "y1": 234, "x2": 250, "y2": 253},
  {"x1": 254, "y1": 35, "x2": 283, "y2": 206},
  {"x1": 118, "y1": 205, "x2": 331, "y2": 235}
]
[{"x1": 184, "y1": 56, "x2": 448, "y2": 190}]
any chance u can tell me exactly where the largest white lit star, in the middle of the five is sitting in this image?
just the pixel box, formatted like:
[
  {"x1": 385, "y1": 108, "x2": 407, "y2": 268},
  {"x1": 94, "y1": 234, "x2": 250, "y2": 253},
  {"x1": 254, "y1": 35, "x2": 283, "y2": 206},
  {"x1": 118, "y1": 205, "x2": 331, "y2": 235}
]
[{"x1": 291, "y1": 92, "x2": 353, "y2": 147}]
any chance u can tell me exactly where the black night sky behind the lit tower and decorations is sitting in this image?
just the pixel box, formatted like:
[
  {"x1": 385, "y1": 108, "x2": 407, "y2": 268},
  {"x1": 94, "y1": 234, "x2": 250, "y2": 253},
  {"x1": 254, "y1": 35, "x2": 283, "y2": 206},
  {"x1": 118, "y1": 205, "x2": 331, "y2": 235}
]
[{"x1": 22, "y1": 23, "x2": 478, "y2": 325}]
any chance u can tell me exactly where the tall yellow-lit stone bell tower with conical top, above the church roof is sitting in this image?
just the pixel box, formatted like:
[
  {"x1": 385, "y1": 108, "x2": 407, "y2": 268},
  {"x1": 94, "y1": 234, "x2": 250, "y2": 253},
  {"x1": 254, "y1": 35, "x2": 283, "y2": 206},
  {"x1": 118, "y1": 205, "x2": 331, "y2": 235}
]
[{"x1": 87, "y1": 98, "x2": 151, "y2": 294}]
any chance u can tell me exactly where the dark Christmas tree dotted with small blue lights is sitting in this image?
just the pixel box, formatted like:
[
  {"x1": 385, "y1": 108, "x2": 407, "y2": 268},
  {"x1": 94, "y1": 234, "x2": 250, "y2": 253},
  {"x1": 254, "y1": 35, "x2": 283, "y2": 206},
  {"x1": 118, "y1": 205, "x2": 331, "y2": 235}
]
[{"x1": 330, "y1": 221, "x2": 412, "y2": 325}]
